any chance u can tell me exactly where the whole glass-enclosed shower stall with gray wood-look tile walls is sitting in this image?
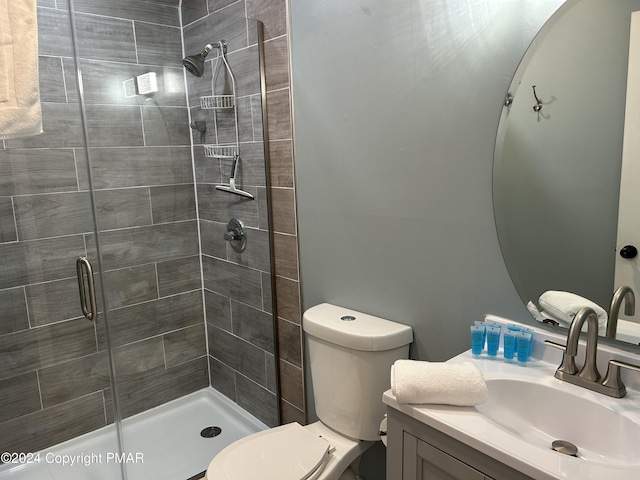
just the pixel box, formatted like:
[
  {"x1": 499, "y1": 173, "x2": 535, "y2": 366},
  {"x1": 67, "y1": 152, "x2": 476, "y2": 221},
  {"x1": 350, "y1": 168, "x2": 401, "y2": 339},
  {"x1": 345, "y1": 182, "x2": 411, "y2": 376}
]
[{"x1": 0, "y1": 0, "x2": 280, "y2": 480}]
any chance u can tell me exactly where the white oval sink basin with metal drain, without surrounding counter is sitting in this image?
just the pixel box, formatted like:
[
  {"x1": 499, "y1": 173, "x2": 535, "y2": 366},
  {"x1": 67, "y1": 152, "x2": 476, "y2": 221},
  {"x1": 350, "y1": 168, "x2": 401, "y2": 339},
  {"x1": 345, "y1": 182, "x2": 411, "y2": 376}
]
[{"x1": 476, "y1": 378, "x2": 640, "y2": 466}]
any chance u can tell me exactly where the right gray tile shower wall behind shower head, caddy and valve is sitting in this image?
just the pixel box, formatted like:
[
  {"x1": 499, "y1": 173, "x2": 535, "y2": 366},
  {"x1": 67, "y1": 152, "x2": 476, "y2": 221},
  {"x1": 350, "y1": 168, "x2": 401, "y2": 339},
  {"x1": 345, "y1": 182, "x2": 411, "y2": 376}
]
[{"x1": 183, "y1": 9, "x2": 279, "y2": 426}]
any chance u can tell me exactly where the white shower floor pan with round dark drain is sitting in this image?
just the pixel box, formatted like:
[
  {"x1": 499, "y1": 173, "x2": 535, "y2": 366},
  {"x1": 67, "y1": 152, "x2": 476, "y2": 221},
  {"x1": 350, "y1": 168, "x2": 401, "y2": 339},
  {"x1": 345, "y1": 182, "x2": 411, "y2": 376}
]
[{"x1": 0, "y1": 388, "x2": 268, "y2": 480}]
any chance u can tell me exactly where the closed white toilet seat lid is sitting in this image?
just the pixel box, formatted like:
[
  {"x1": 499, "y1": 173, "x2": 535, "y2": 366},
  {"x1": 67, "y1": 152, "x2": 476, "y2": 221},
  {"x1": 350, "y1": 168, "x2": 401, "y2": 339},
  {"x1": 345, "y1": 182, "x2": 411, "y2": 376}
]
[{"x1": 207, "y1": 423, "x2": 331, "y2": 480}]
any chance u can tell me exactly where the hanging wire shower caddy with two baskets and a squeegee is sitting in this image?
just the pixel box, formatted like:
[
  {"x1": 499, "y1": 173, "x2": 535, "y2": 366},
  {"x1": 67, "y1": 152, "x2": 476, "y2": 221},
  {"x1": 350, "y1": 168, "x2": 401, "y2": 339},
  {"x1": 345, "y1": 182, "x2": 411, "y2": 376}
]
[{"x1": 200, "y1": 40, "x2": 253, "y2": 199}]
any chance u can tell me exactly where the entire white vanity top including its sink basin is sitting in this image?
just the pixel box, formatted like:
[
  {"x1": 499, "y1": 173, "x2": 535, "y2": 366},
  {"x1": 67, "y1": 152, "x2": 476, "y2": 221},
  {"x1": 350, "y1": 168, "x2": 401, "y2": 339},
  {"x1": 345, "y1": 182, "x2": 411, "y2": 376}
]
[{"x1": 383, "y1": 315, "x2": 640, "y2": 480}]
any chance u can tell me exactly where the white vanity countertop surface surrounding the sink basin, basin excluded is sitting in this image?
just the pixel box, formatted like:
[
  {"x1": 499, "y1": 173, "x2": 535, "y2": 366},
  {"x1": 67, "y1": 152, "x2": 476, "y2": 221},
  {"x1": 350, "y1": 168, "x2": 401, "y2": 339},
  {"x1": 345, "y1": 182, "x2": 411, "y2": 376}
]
[{"x1": 383, "y1": 316, "x2": 640, "y2": 480}]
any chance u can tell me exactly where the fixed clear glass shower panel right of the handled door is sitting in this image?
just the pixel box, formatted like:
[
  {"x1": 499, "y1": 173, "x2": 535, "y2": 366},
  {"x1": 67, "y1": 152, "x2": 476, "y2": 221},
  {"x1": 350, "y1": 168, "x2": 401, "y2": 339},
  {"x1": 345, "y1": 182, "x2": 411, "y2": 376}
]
[{"x1": 63, "y1": 0, "x2": 279, "y2": 479}]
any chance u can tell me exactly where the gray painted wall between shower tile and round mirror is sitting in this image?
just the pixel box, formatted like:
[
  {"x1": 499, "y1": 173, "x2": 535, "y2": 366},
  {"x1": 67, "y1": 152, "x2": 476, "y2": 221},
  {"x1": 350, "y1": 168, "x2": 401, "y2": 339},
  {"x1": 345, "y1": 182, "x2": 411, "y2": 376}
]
[{"x1": 289, "y1": 0, "x2": 562, "y2": 480}]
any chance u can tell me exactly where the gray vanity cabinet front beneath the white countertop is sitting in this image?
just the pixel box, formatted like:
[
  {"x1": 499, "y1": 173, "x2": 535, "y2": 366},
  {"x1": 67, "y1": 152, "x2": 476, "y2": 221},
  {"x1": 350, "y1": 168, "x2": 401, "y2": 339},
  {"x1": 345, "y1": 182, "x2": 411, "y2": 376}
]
[{"x1": 387, "y1": 408, "x2": 533, "y2": 480}]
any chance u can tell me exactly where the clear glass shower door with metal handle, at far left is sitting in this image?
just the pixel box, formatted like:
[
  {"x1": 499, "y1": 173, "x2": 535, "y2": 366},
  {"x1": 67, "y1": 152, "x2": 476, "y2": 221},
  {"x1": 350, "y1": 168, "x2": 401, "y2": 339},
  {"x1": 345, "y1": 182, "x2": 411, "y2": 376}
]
[{"x1": 0, "y1": 2, "x2": 122, "y2": 480}]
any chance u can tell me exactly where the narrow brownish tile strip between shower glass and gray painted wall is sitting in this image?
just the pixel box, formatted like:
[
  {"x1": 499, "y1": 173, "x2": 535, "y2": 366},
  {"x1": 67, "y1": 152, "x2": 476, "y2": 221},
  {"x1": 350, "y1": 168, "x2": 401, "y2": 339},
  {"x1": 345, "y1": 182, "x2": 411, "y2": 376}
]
[{"x1": 182, "y1": 0, "x2": 306, "y2": 424}]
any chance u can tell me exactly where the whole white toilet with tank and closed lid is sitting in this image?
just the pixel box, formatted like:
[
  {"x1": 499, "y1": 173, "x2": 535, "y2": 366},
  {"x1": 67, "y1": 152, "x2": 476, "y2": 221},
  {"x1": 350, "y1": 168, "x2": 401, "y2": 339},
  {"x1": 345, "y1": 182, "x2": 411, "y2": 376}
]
[{"x1": 205, "y1": 303, "x2": 413, "y2": 480}]
